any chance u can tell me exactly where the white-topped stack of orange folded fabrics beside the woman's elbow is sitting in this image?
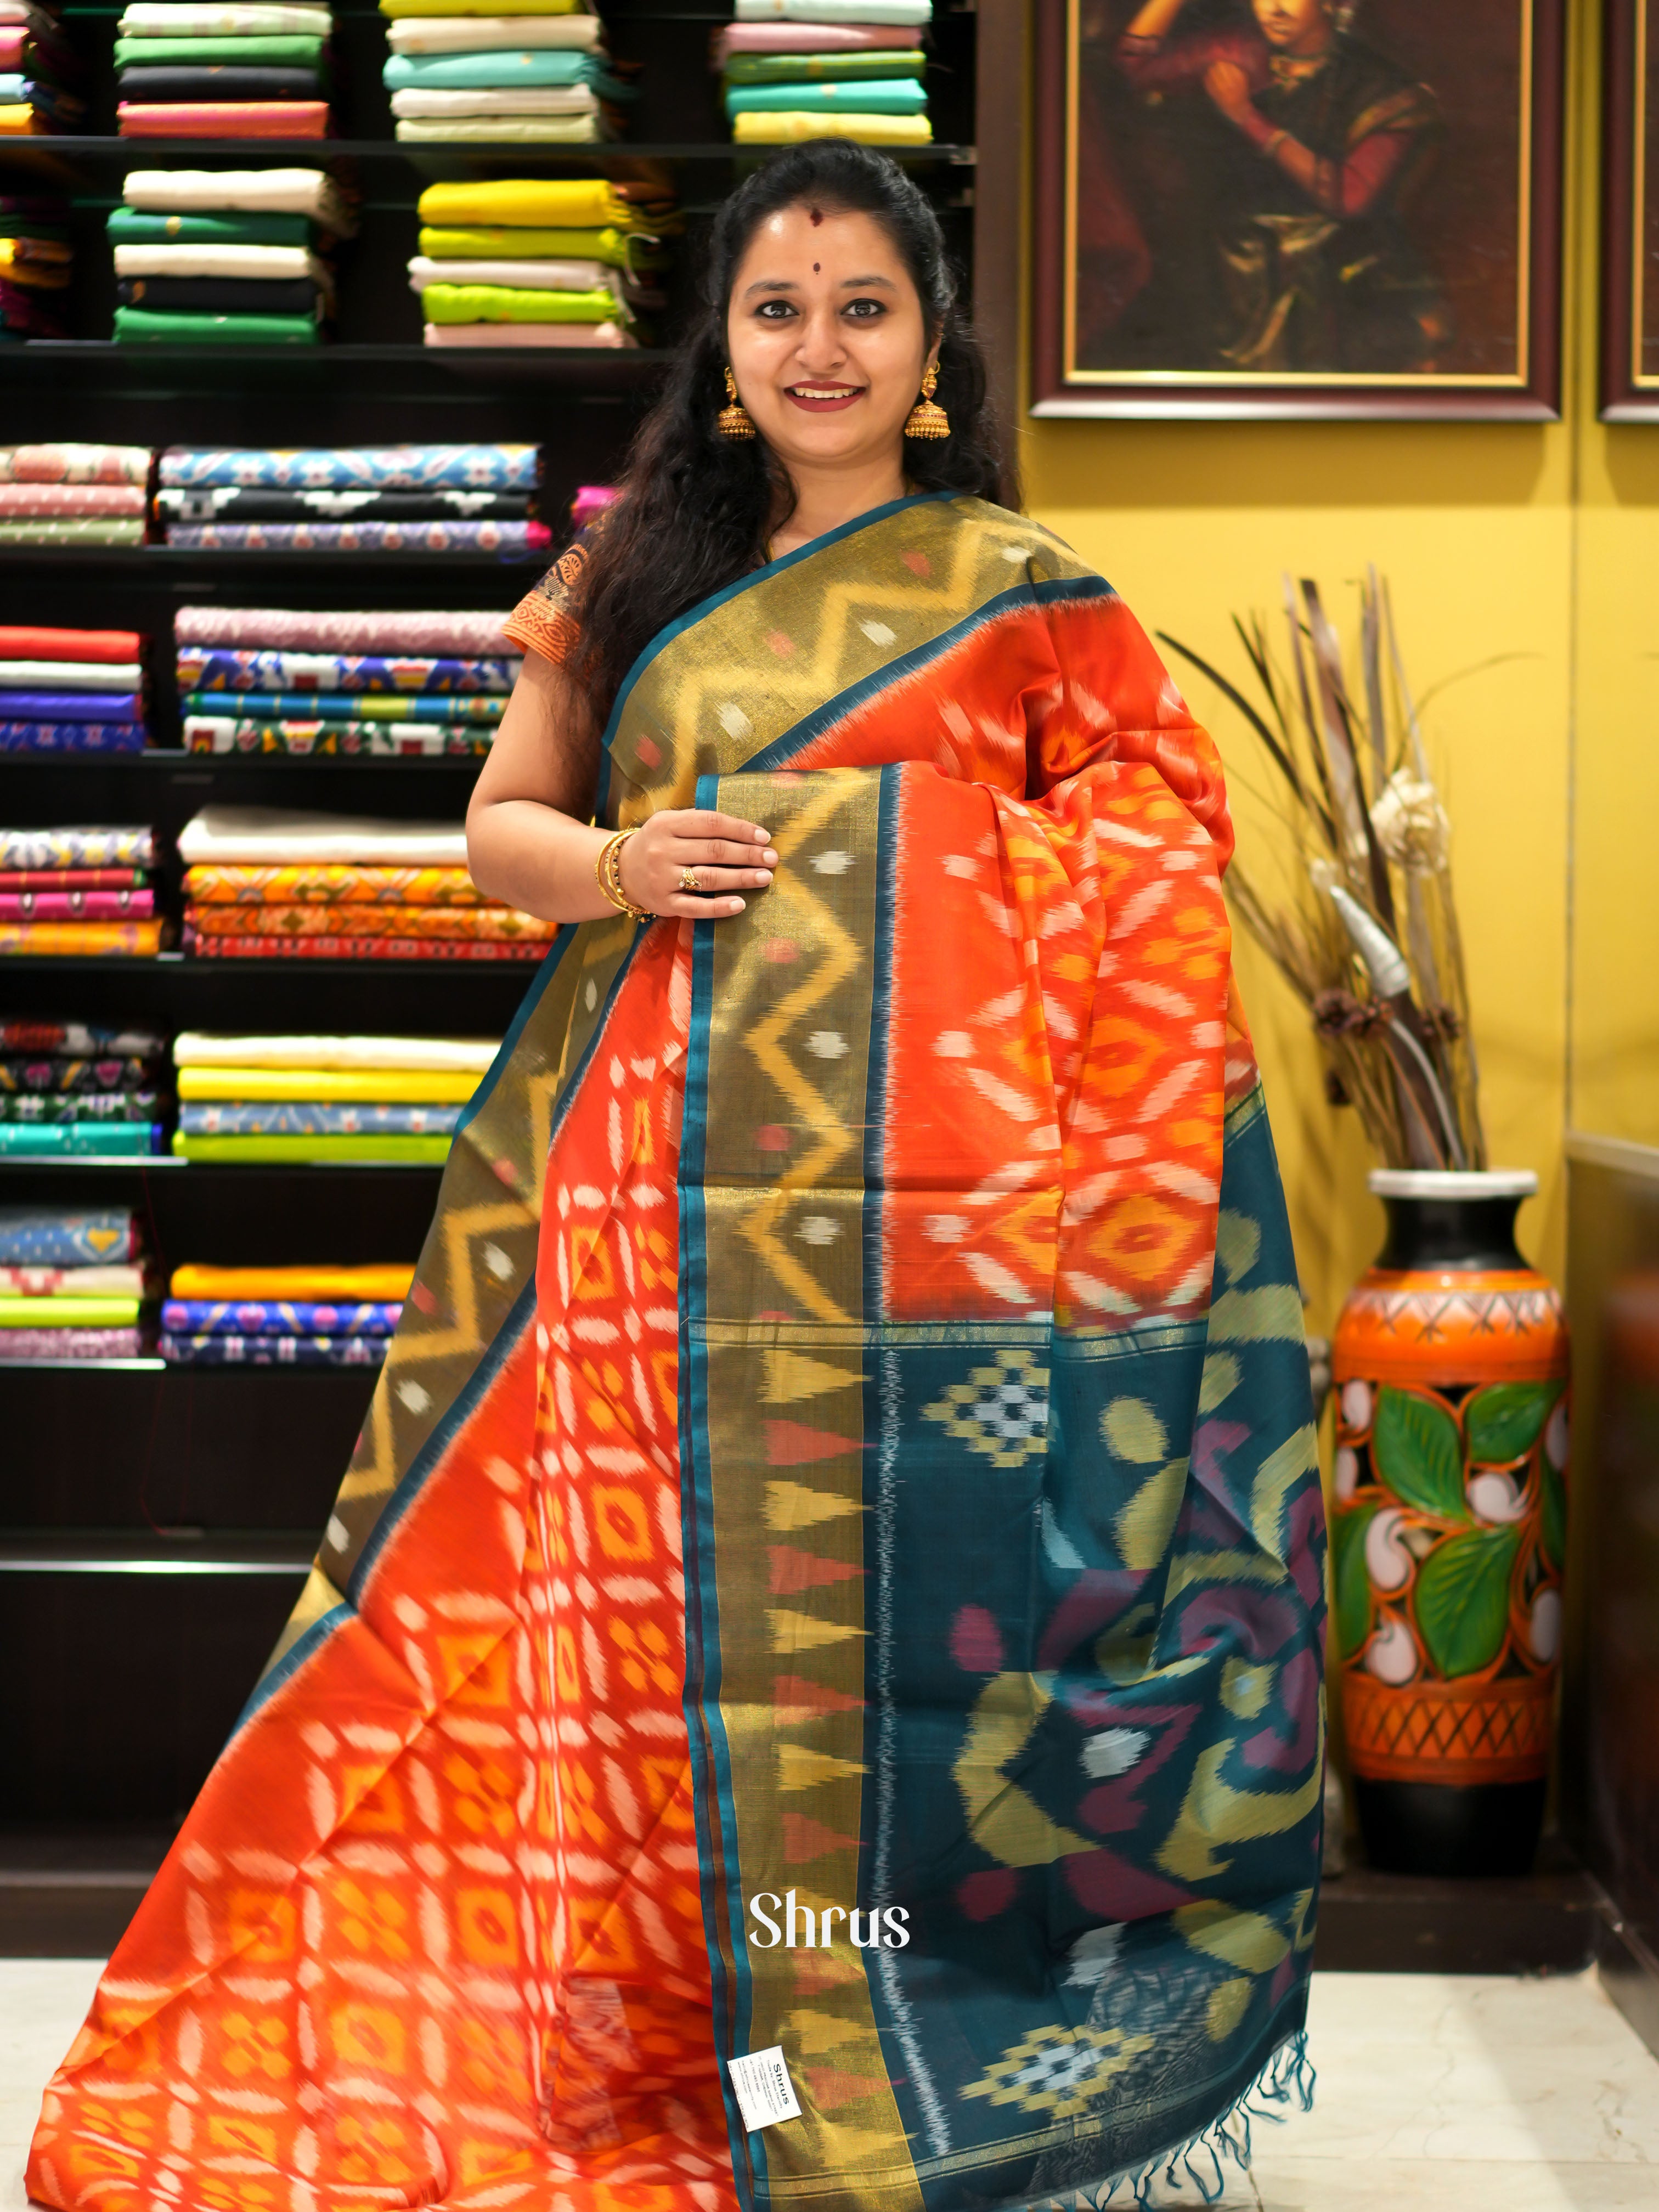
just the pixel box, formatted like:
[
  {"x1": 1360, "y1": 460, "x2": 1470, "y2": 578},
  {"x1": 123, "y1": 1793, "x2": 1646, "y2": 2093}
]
[{"x1": 179, "y1": 808, "x2": 555, "y2": 960}]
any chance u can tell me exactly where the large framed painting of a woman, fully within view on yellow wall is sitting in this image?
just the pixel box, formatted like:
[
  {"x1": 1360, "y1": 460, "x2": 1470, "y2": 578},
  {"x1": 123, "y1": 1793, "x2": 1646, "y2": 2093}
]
[{"x1": 1033, "y1": 0, "x2": 1566, "y2": 420}]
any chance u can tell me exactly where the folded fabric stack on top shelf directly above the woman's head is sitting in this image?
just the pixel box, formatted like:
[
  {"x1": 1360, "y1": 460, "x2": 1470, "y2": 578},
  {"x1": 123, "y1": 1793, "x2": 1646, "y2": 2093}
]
[{"x1": 714, "y1": 0, "x2": 934, "y2": 146}]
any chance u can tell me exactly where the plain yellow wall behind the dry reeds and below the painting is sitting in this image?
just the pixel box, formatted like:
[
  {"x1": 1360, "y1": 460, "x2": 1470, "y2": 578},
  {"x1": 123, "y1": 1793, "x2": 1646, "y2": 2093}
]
[{"x1": 1020, "y1": 0, "x2": 1659, "y2": 1327}]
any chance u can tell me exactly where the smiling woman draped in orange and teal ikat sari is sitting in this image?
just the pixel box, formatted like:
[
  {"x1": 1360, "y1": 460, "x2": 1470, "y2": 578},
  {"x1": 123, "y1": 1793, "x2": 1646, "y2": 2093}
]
[{"x1": 29, "y1": 144, "x2": 1323, "y2": 2212}]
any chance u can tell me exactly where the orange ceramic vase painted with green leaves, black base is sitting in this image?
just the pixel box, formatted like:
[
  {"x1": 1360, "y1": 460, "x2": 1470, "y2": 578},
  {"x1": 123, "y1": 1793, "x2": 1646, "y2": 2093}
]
[{"x1": 1331, "y1": 1170, "x2": 1568, "y2": 1874}]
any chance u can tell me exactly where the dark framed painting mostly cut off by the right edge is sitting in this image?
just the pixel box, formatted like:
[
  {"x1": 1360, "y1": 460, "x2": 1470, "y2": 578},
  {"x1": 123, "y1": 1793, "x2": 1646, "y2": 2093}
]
[{"x1": 1601, "y1": 0, "x2": 1659, "y2": 422}]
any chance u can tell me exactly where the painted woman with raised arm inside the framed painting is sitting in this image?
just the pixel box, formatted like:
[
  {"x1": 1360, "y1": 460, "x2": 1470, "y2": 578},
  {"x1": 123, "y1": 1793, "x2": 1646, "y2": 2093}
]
[{"x1": 1117, "y1": 0, "x2": 1449, "y2": 376}]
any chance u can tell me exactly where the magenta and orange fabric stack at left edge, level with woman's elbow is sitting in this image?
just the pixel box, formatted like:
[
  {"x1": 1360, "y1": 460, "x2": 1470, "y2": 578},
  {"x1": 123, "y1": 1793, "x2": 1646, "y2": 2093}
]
[{"x1": 0, "y1": 827, "x2": 172, "y2": 956}]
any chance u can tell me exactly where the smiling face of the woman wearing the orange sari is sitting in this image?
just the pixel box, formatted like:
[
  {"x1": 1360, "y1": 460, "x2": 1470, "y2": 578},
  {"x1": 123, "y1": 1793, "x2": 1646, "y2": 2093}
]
[{"x1": 725, "y1": 206, "x2": 929, "y2": 471}]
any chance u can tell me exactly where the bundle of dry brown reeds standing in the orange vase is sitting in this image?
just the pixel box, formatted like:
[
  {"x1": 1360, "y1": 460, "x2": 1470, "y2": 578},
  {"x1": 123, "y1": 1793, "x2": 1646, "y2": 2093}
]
[{"x1": 1159, "y1": 568, "x2": 1487, "y2": 1168}]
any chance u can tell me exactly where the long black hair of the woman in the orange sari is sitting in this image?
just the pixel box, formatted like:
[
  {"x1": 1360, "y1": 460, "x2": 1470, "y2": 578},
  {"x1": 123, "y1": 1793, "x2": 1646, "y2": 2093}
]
[{"x1": 577, "y1": 139, "x2": 1009, "y2": 721}]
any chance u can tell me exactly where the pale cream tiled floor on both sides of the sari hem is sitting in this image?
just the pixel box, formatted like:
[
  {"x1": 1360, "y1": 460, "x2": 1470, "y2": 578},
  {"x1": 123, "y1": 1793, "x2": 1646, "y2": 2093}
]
[{"x1": 0, "y1": 1957, "x2": 1659, "y2": 2212}]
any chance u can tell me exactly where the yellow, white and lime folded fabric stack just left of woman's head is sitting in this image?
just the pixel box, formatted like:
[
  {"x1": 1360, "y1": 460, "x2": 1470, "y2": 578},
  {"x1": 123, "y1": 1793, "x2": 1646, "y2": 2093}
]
[{"x1": 409, "y1": 177, "x2": 684, "y2": 345}]
